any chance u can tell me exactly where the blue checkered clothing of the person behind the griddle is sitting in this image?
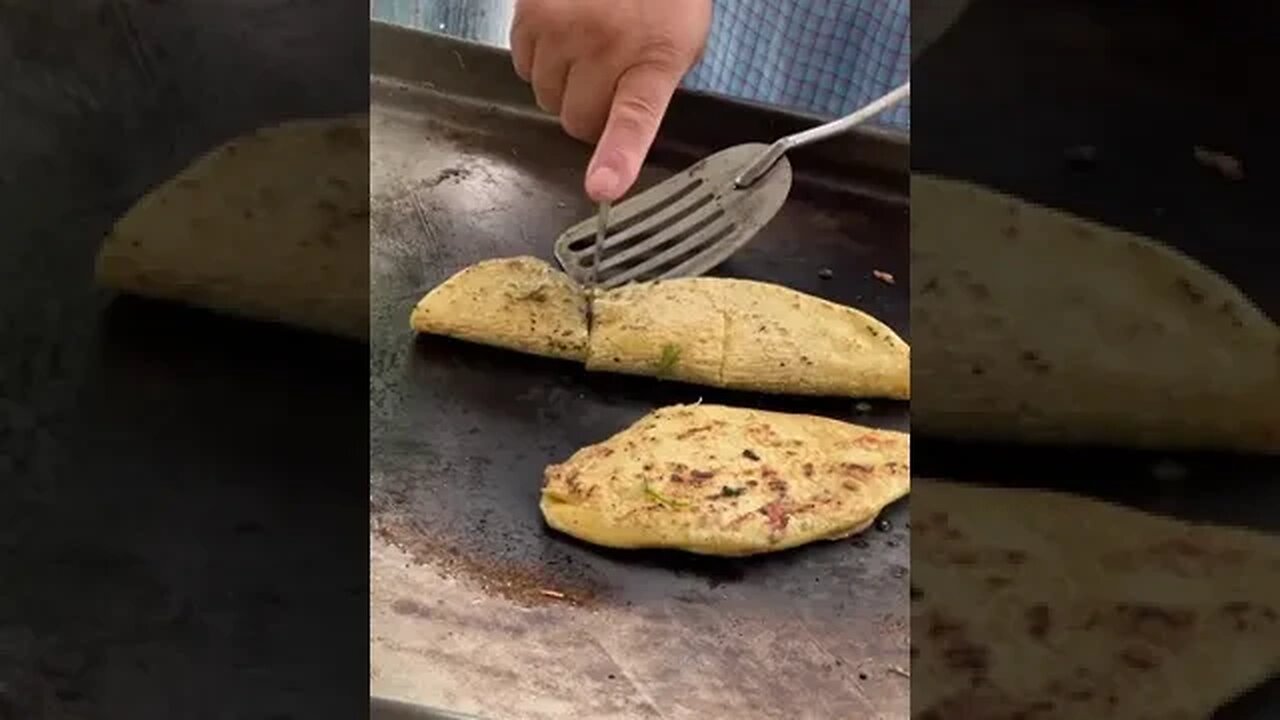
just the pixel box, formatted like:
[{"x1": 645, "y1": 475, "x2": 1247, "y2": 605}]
[{"x1": 370, "y1": 0, "x2": 911, "y2": 129}]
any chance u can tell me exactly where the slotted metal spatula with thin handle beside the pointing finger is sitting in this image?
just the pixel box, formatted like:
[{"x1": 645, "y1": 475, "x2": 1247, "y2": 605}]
[{"x1": 556, "y1": 82, "x2": 911, "y2": 290}]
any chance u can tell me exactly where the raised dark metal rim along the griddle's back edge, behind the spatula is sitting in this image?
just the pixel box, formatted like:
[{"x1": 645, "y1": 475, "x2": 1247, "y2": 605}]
[{"x1": 369, "y1": 20, "x2": 911, "y2": 199}]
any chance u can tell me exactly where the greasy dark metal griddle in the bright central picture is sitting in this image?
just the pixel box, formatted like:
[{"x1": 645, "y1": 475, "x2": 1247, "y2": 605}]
[{"x1": 370, "y1": 23, "x2": 909, "y2": 717}]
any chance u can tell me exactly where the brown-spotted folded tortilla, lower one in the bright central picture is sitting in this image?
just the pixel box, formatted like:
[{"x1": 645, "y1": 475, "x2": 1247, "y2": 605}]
[{"x1": 540, "y1": 405, "x2": 910, "y2": 556}]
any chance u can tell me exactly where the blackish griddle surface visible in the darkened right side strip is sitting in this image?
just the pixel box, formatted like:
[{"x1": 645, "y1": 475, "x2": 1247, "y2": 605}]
[{"x1": 911, "y1": 0, "x2": 1280, "y2": 720}]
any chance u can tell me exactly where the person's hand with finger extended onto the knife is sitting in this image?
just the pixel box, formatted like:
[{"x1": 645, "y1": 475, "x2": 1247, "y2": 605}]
[{"x1": 511, "y1": 0, "x2": 712, "y2": 202}]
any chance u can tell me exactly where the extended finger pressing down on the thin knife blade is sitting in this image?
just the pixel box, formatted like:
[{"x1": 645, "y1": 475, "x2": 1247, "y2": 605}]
[{"x1": 585, "y1": 64, "x2": 680, "y2": 202}]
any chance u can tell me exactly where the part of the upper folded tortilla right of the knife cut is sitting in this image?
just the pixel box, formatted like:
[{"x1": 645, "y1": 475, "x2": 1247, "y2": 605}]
[{"x1": 586, "y1": 278, "x2": 911, "y2": 400}]
